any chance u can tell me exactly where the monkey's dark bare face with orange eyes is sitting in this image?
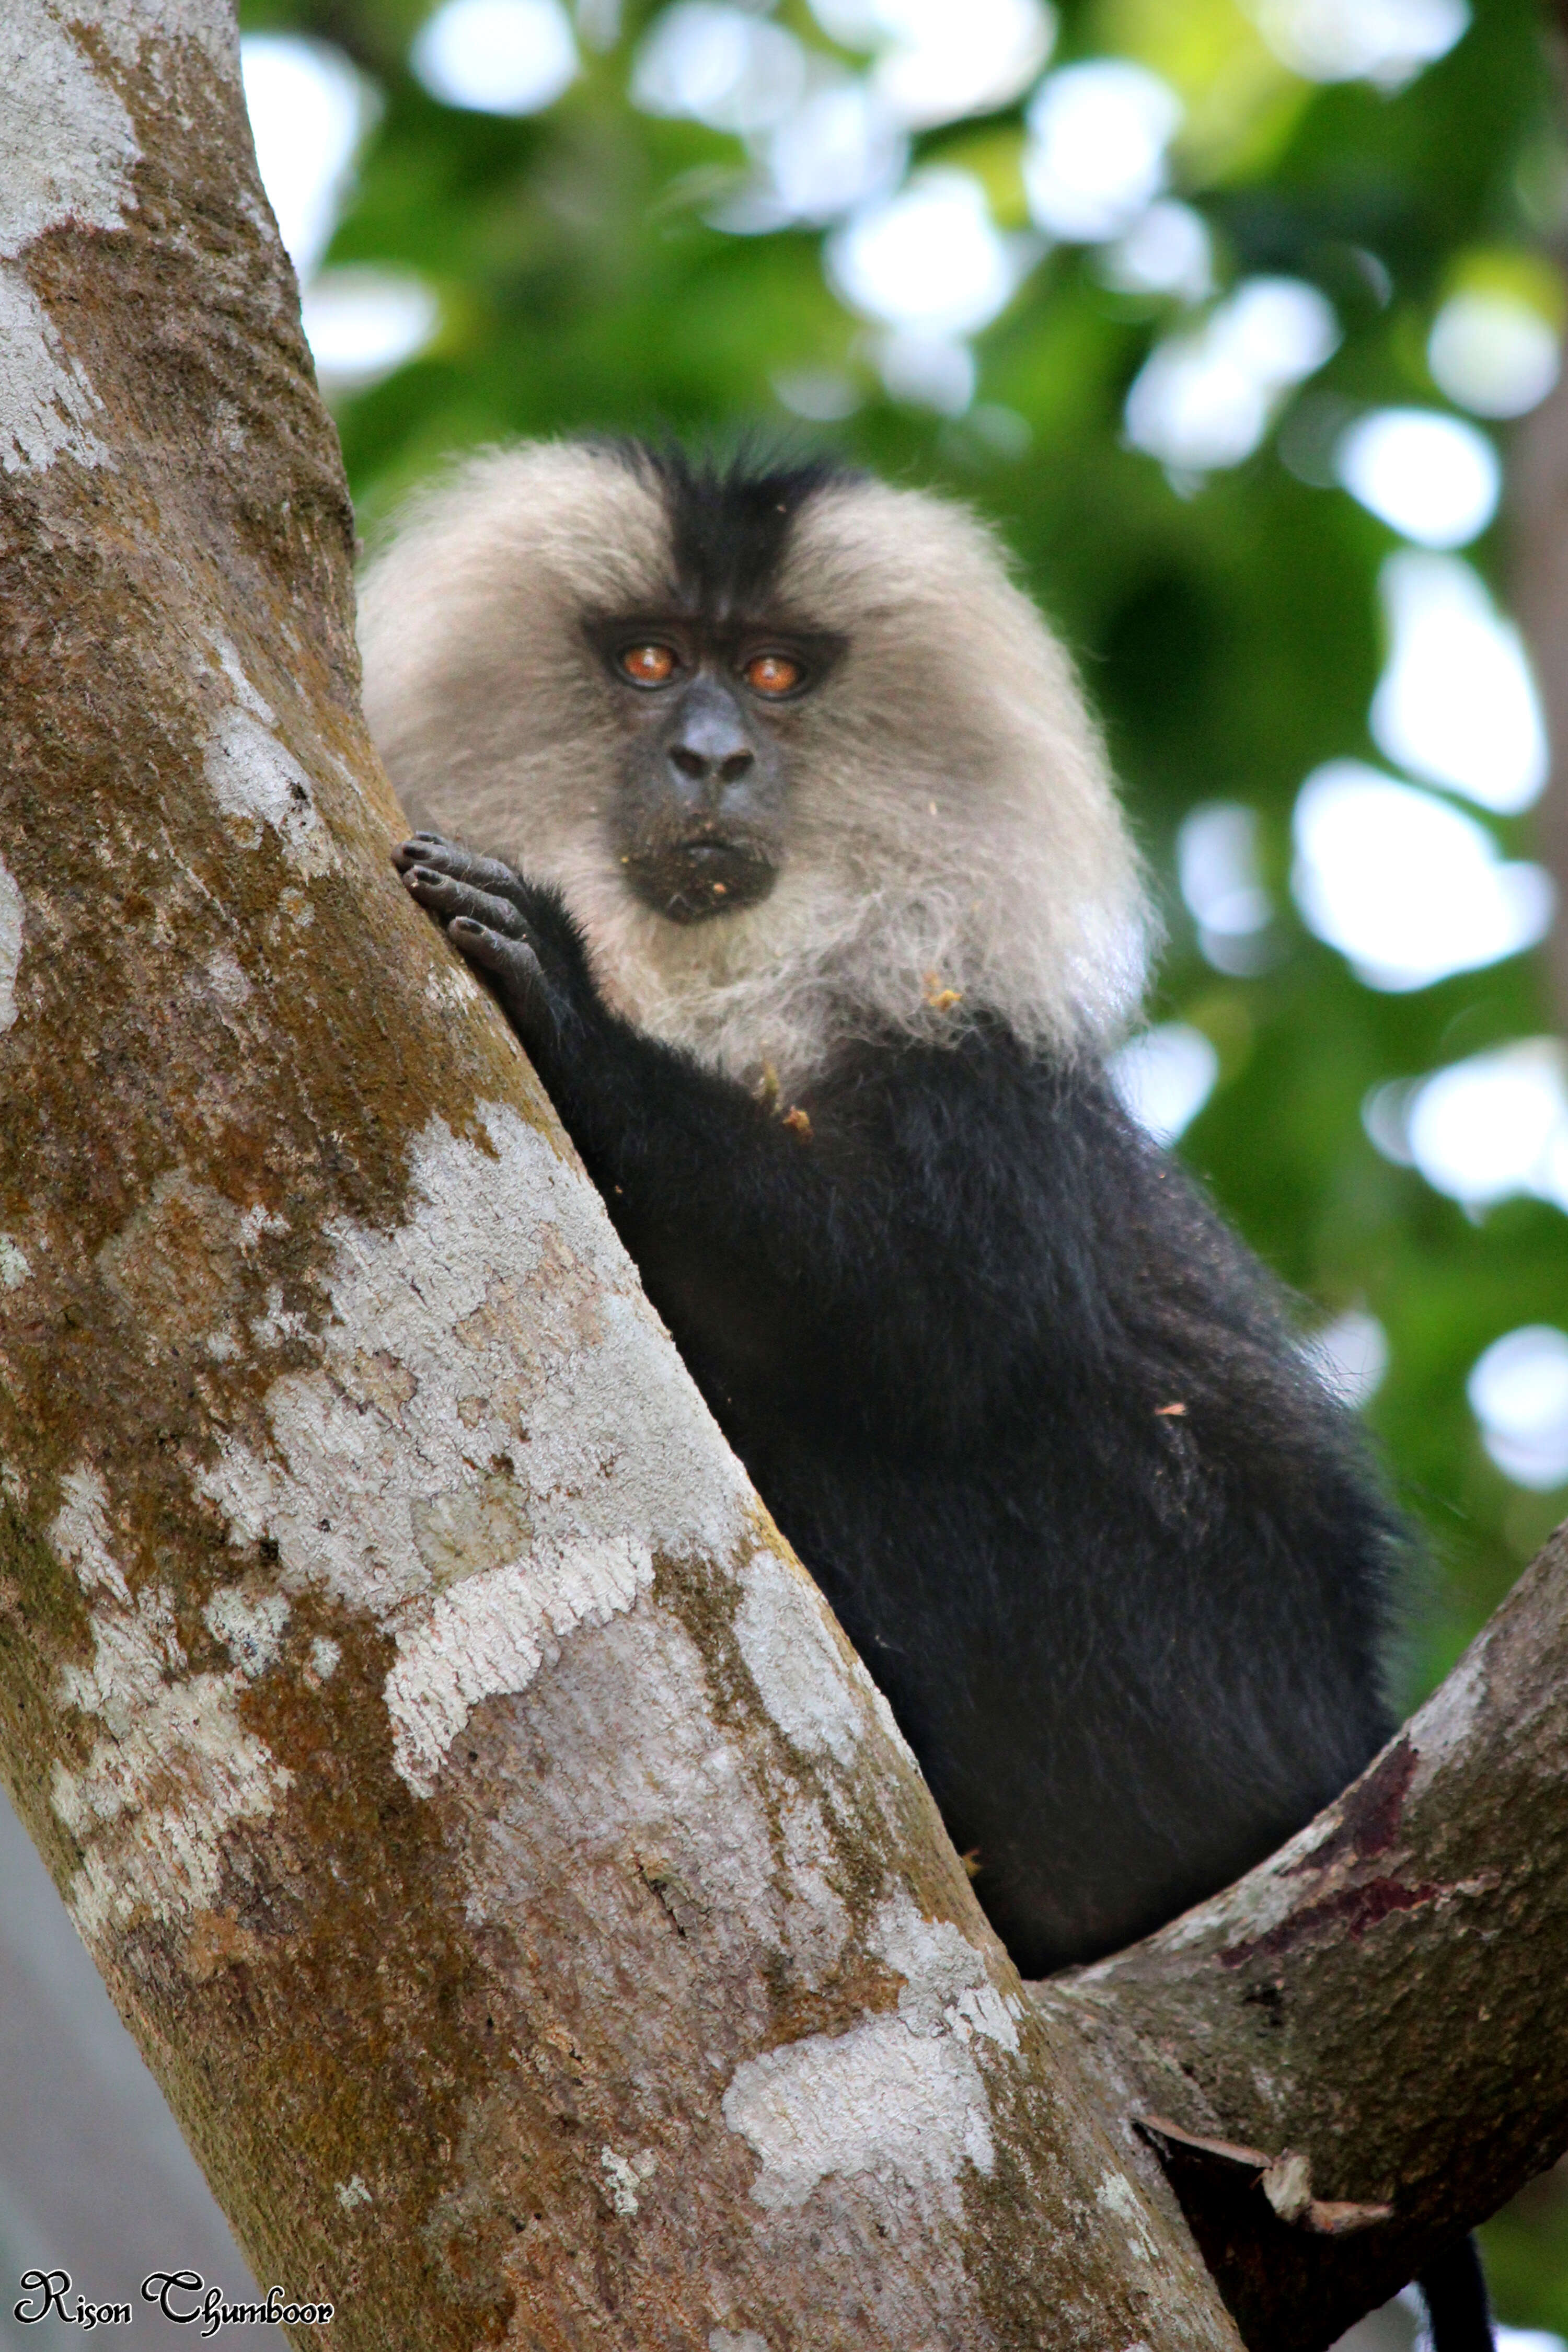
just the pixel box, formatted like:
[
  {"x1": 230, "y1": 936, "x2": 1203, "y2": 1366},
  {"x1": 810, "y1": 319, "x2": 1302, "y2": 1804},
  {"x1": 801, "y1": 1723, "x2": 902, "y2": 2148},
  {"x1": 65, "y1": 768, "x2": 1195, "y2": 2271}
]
[{"x1": 590, "y1": 614, "x2": 839, "y2": 925}]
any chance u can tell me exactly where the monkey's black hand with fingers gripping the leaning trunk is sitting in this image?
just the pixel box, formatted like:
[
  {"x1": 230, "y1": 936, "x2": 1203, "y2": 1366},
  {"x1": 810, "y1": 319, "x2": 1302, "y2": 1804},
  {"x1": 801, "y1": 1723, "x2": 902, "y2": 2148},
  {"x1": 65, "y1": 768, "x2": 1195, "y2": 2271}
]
[{"x1": 393, "y1": 833, "x2": 597, "y2": 1054}]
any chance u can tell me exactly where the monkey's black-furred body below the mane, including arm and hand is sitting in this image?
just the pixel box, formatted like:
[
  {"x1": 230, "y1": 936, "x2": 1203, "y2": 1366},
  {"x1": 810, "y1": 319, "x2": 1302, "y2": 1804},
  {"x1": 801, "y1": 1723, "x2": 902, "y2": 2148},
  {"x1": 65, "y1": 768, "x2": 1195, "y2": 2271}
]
[{"x1": 400, "y1": 835, "x2": 1399, "y2": 1976}]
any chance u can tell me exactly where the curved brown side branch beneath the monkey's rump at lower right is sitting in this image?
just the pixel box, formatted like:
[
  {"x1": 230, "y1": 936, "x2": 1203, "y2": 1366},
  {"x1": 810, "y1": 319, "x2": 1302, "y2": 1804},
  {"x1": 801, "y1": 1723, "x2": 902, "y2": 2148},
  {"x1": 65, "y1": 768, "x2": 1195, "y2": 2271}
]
[{"x1": 1034, "y1": 1531, "x2": 1568, "y2": 2352}]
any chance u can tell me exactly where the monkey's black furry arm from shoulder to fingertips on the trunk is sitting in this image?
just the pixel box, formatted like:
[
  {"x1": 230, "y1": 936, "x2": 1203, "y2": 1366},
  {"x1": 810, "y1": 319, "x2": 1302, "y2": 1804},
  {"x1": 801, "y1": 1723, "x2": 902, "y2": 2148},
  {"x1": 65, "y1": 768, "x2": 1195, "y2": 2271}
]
[{"x1": 397, "y1": 835, "x2": 1079, "y2": 1444}]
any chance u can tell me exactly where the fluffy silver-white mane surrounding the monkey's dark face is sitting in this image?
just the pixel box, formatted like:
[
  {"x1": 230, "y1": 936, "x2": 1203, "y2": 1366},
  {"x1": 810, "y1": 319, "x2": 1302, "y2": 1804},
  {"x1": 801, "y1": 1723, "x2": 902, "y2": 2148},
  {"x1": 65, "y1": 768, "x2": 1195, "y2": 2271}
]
[{"x1": 360, "y1": 445, "x2": 1149, "y2": 1089}]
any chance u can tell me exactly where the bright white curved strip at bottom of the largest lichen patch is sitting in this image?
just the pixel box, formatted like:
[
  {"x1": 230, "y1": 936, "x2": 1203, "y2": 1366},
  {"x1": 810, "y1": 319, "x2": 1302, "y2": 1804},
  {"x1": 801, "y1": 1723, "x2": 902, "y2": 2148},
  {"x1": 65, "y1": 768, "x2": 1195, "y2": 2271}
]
[{"x1": 386, "y1": 1536, "x2": 653, "y2": 1797}]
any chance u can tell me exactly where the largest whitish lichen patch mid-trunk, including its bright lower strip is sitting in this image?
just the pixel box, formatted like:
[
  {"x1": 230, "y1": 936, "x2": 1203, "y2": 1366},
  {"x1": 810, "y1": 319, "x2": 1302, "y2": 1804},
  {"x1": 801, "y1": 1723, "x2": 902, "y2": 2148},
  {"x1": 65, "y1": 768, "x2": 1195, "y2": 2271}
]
[{"x1": 198, "y1": 1105, "x2": 750, "y2": 1795}]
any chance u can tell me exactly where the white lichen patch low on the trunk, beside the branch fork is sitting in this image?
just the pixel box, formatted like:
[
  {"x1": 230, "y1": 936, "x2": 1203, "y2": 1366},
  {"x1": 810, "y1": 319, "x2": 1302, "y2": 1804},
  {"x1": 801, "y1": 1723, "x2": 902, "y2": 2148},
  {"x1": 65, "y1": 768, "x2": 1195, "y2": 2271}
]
[{"x1": 724, "y1": 1891, "x2": 1018, "y2": 2211}]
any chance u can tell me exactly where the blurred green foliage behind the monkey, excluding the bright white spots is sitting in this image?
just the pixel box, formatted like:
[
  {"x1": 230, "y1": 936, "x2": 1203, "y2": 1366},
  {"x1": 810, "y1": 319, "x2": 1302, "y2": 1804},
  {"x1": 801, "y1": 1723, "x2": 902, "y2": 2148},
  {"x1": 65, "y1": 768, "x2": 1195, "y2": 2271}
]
[{"x1": 245, "y1": 0, "x2": 1568, "y2": 2331}]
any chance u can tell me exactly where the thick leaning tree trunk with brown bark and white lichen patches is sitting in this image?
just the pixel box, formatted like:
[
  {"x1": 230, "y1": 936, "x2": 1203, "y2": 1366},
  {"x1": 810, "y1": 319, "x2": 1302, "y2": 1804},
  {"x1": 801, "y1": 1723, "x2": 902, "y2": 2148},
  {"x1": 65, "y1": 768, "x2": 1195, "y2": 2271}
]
[{"x1": 0, "y1": 0, "x2": 1234, "y2": 2352}]
